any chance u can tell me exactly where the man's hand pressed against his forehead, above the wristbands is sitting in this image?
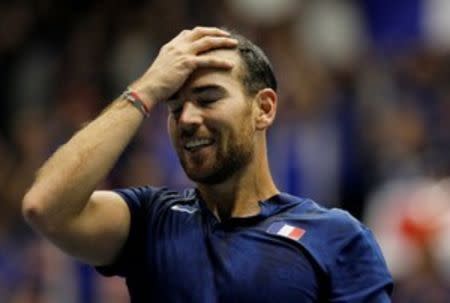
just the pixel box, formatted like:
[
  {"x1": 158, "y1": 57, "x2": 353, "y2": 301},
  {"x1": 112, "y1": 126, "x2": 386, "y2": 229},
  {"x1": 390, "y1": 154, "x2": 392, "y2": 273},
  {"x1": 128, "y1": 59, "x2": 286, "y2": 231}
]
[{"x1": 131, "y1": 27, "x2": 238, "y2": 107}]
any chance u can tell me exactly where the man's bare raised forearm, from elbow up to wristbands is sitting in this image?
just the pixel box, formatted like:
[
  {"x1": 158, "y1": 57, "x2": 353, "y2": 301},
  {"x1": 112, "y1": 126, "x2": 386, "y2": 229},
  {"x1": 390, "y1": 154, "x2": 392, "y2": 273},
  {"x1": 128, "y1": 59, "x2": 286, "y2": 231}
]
[{"x1": 23, "y1": 100, "x2": 149, "y2": 228}]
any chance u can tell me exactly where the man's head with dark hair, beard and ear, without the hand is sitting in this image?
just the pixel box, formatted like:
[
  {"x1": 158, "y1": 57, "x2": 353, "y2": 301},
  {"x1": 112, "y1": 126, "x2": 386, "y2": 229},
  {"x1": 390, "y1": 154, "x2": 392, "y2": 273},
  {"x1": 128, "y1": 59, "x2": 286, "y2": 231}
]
[{"x1": 168, "y1": 29, "x2": 277, "y2": 184}]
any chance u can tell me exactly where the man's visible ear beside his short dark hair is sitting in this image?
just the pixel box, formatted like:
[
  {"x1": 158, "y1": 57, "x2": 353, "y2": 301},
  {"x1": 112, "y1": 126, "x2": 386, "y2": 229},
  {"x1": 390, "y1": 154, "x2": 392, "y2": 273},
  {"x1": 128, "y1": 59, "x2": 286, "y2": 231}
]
[{"x1": 255, "y1": 88, "x2": 278, "y2": 130}]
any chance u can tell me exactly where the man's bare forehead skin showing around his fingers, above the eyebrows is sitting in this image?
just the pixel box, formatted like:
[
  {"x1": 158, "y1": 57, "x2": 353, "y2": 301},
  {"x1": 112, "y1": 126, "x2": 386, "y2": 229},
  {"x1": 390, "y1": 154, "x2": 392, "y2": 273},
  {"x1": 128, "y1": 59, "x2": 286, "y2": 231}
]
[{"x1": 178, "y1": 49, "x2": 242, "y2": 93}]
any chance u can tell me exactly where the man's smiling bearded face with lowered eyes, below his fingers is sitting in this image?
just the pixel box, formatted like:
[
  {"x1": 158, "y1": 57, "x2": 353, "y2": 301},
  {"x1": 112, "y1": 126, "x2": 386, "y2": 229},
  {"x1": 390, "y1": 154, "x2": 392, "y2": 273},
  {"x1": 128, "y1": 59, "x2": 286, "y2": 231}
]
[{"x1": 167, "y1": 50, "x2": 255, "y2": 184}]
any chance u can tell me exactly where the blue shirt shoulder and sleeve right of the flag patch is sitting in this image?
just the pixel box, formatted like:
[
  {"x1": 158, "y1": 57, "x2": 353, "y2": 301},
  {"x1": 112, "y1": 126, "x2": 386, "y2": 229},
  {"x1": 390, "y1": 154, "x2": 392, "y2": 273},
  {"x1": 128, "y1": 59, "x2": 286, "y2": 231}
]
[{"x1": 280, "y1": 196, "x2": 392, "y2": 302}]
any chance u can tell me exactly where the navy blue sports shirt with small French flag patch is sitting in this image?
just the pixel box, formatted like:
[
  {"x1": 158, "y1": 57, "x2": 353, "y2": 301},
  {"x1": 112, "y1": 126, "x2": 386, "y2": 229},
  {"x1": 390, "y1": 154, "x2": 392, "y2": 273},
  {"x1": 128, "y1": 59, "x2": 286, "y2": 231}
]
[{"x1": 98, "y1": 187, "x2": 392, "y2": 303}]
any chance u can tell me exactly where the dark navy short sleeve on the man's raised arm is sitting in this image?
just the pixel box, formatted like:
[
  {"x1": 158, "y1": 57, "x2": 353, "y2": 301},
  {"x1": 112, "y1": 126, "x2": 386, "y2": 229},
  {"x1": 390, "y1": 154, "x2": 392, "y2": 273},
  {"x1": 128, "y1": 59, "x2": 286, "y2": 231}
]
[{"x1": 96, "y1": 186, "x2": 171, "y2": 277}]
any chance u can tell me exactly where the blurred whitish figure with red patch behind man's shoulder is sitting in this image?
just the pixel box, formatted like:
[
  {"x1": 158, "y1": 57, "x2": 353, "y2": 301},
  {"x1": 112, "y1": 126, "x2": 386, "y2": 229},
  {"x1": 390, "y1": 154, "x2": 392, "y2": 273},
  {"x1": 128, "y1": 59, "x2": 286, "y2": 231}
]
[{"x1": 366, "y1": 178, "x2": 450, "y2": 303}]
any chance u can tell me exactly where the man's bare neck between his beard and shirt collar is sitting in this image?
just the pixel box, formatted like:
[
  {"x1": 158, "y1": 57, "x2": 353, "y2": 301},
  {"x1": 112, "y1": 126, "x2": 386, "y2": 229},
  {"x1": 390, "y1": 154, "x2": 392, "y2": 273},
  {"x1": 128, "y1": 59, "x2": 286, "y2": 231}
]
[{"x1": 197, "y1": 144, "x2": 279, "y2": 220}]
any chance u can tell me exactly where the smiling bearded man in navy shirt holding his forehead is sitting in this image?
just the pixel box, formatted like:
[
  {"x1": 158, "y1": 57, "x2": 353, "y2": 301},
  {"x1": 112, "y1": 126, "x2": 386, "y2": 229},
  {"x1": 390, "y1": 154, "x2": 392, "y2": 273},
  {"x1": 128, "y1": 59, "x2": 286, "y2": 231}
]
[{"x1": 23, "y1": 27, "x2": 392, "y2": 303}]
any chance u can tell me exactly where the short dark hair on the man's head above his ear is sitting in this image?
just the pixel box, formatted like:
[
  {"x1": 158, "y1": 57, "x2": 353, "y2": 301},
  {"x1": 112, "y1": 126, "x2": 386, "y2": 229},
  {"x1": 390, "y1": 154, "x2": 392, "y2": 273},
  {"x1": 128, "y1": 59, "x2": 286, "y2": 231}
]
[{"x1": 226, "y1": 29, "x2": 277, "y2": 96}]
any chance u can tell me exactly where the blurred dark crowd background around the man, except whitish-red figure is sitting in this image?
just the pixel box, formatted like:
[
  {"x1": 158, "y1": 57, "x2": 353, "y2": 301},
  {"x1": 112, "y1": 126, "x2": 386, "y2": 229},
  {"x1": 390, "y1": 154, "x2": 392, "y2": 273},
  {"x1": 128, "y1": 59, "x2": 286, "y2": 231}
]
[{"x1": 0, "y1": 0, "x2": 450, "y2": 303}]
